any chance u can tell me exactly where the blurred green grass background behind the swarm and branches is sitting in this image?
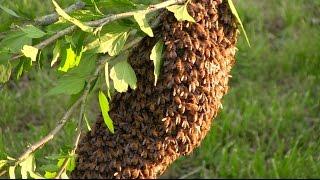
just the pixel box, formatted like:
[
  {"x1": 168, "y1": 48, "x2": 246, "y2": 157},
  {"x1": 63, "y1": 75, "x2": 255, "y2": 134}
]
[{"x1": 0, "y1": 0, "x2": 320, "y2": 178}]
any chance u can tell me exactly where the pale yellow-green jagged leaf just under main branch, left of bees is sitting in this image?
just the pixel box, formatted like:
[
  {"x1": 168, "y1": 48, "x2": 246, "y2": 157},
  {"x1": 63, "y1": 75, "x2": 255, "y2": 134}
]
[{"x1": 97, "y1": 32, "x2": 128, "y2": 56}]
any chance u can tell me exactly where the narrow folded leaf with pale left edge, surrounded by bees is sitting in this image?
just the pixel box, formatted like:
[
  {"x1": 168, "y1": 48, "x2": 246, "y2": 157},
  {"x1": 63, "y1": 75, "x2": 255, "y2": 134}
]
[{"x1": 150, "y1": 40, "x2": 163, "y2": 86}]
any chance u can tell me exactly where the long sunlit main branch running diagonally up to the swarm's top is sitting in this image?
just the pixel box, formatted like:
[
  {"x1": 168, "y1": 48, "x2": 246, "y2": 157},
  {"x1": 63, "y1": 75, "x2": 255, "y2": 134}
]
[{"x1": 11, "y1": 0, "x2": 185, "y2": 60}]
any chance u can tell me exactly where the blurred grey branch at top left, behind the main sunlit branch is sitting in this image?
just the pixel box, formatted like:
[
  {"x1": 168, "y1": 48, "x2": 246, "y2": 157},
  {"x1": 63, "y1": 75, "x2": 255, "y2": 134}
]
[{"x1": 34, "y1": 0, "x2": 86, "y2": 26}]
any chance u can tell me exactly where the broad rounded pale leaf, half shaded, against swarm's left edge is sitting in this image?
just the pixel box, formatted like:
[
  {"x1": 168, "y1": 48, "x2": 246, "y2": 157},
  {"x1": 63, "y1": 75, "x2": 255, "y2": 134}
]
[{"x1": 110, "y1": 61, "x2": 137, "y2": 92}]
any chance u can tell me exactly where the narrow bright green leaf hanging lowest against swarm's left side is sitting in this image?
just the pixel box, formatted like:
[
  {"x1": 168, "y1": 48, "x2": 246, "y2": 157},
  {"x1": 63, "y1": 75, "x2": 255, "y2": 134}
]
[{"x1": 99, "y1": 91, "x2": 114, "y2": 134}]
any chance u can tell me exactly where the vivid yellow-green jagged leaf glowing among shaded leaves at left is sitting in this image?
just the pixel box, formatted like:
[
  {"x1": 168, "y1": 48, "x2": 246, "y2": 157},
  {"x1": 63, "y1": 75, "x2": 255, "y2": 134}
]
[{"x1": 58, "y1": 45, "x2": 84, "y2": 72}]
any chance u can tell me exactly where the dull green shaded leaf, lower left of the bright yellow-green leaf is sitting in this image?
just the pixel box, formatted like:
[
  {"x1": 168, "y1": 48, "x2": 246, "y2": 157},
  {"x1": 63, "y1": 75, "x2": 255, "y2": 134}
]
[{"x1": 47, "y1": 76, "x2": 85, "y2": 96}]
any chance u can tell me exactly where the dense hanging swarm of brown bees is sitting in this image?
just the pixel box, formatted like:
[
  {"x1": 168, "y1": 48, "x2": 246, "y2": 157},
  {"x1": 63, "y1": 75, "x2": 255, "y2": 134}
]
[{"x1": 72, "y1": 0, "x2": 237, "y2": 178}]
